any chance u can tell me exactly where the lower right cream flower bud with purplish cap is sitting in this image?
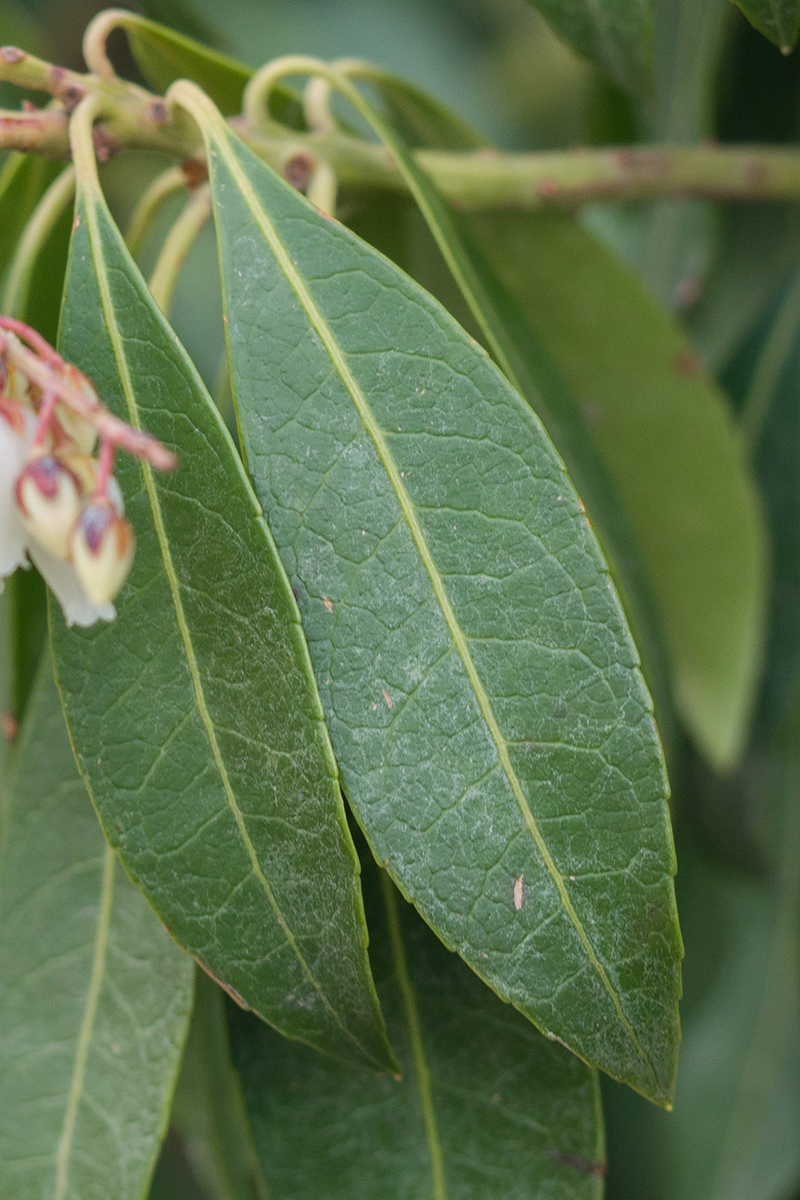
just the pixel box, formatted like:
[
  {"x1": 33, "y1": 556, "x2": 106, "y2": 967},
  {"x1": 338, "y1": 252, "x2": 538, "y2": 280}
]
[{"x1": 71, "y1": 497, "x2": 134, "y2": 605}]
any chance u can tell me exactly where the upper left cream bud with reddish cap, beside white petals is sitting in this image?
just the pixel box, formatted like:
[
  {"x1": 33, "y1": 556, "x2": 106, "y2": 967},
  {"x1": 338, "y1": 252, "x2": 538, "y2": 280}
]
[{"x1": 16, "y1": 454, "x2": 80, "y2": 558}]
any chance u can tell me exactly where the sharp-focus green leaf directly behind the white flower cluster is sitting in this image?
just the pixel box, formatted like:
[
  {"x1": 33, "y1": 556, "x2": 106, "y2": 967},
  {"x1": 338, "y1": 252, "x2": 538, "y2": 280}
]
[{"x1": 54, "y1": 136, "x2": 392, "y2": 1066}]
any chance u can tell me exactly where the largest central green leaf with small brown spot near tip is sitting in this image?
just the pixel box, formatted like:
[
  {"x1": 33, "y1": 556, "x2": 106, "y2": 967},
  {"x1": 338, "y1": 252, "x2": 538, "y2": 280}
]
[{"x1": 184, "y1": 85, "x2": 680, "y2": 1103}]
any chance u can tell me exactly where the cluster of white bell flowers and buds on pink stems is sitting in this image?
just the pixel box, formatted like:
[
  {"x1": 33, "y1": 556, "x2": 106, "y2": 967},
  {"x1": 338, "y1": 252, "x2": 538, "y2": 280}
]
[{"x1": 0, "y1": 318, "x2": 158, "y2": 625}]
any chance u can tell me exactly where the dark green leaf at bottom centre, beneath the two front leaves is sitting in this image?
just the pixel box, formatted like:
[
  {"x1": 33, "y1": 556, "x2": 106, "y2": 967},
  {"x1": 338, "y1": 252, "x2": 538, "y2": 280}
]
[{"x1": 231, "y1": 865, "x2": 604, "y2": 1200}]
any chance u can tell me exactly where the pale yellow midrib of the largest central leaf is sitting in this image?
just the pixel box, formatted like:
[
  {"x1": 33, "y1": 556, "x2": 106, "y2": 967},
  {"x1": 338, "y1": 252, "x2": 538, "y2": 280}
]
[{"x1": 211, "y1": 129, "x2": 658, "y2": 1087}]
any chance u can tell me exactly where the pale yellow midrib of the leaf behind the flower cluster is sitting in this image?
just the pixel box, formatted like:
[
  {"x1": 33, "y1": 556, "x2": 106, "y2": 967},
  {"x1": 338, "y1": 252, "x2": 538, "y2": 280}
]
[{"x1": 85, "y1": 197, "x2": 374, "y2": 1061}]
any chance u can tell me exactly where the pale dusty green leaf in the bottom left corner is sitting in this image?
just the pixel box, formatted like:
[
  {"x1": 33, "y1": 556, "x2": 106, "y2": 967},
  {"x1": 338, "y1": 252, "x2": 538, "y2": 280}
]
[{"x1": 0, "y1": 661, "x2": 193, "y2": 1200}]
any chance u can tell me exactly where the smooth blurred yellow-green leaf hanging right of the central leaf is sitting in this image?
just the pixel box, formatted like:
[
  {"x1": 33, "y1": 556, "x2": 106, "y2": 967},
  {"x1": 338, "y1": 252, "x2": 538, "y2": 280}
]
[{"x1": 473, "y1": 214, "x2": 766, "y2": 766}]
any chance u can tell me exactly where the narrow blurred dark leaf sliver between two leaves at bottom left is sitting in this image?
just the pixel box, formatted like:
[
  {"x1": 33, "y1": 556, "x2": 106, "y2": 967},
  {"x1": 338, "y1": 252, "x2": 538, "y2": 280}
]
[{"x1": 172, "y1": 971, "x2": 267, "y2": 1200}]
